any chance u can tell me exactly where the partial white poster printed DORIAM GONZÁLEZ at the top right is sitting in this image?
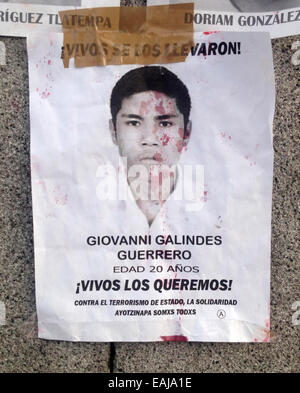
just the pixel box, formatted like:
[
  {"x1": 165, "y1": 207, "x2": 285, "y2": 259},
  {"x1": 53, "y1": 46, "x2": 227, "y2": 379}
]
[{"x1": 147, "y1": 0, "x2": 300, "y2": 38}]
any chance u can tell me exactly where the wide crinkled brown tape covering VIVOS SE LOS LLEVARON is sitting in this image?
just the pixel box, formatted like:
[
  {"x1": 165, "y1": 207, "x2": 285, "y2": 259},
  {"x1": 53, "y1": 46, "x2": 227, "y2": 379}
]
[{"x1": 59, "y1": 3, "x2": 194, "y2": 68}]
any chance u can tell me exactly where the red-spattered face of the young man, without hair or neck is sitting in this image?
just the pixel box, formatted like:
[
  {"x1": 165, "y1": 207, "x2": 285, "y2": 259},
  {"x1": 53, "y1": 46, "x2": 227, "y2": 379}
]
[{"x1": 111, "y1": 91, "x2": 191, "y2": 168}]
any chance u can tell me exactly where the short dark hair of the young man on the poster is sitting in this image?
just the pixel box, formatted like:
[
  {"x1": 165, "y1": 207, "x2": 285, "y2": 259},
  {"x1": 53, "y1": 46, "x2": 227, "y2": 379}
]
[{"x1": 110, "y1": 66, "x2": 191, "y2": 130}]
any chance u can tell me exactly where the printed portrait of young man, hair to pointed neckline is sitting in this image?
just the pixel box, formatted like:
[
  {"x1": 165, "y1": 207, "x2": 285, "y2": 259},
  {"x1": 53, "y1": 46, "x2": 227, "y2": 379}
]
[{"x1": 110, "y1": 66, "x2": 191, "y2": 226}]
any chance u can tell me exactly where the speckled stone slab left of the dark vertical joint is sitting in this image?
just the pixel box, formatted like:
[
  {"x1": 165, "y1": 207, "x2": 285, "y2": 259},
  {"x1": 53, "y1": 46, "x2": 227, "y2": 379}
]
[{"x1": 0, "y1": 37, "x2": 110, "y2": 372}]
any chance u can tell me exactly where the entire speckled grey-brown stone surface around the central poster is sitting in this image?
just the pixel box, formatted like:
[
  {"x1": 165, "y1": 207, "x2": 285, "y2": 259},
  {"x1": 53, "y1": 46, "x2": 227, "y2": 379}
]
[{"x1": 0, "y1": 1, "x2": 300, "y2": 373}]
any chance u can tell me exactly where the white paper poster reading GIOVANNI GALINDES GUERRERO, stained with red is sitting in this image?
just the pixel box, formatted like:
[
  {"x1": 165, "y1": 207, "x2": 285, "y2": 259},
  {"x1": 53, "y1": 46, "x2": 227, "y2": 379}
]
[{"x1": 28, "y1": 32, "x2": 275, "y2": 342}]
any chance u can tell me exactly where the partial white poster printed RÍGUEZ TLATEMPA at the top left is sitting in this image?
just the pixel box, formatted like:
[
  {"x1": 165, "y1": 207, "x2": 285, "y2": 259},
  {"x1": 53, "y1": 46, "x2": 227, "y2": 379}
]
[{"x1": 0, "y1": 0, "x2": 120, "y2": 37}]
